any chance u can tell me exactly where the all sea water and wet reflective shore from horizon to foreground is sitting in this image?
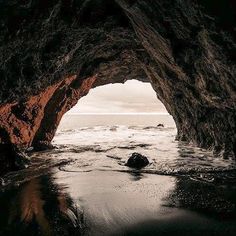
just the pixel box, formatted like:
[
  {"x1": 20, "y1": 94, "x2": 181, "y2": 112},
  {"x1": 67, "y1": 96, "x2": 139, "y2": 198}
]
[{"x1": 0, "y1": 115, "x2": 236, "y2": 235}]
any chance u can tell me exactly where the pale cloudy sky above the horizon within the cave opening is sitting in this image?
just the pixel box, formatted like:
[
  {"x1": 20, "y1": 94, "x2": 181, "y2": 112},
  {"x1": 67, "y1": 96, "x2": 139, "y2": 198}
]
[{"x1": 68, "y1": 80, "x2": 167, "y2": 114}]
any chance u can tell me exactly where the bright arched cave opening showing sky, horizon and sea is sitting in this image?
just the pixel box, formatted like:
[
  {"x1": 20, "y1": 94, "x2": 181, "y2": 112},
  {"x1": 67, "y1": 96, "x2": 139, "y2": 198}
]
[{"x1": 52, "y1": 80, "x2": 176, "y2": 146}]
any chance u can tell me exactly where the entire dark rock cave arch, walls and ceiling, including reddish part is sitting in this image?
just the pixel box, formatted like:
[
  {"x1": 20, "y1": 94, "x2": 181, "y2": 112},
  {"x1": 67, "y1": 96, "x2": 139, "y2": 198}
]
[{"x1": 0, "y1": 0, "x2": 236, "y2": 171}]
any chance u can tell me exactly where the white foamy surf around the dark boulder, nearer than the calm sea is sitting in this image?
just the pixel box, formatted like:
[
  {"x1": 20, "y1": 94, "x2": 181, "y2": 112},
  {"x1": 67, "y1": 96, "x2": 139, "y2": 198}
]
[{"x1": 47, "y1": 125, "x2": 236, "y2": 182}]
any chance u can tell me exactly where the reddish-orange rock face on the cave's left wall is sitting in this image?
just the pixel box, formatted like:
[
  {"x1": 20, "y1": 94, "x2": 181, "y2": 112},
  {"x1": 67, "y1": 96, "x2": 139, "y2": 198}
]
[{"x1": 0, "y1": 76, "x2": 96, "y2": 148}]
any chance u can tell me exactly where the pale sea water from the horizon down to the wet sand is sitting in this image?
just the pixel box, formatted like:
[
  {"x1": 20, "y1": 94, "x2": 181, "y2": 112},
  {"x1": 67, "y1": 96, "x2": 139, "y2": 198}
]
[{"x1": 51, "y1": 115, "x2": 236, "y2": 175}]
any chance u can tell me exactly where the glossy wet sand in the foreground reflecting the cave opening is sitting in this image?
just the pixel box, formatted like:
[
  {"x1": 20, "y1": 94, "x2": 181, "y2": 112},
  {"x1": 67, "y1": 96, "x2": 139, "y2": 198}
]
[{"x1": 0, "y1": 168, "x2": 236, "y2": 235}]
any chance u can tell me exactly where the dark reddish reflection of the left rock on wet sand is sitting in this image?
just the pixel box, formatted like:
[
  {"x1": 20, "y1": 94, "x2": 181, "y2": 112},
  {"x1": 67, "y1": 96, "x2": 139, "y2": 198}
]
[{"x1": 0, "y1": 172, "x2": 83, "y2": 235}]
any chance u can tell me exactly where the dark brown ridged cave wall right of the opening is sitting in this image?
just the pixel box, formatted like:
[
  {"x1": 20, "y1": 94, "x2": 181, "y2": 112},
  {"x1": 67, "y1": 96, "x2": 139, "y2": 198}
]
[{"x1": 121, "y1": 1, "x2": 236, "y2": 156}]
